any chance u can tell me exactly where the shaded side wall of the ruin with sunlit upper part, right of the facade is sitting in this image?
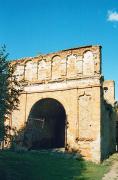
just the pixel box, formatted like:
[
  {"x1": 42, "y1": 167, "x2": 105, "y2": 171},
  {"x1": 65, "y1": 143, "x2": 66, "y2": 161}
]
[{"x1": 101, "y1": 80, "x2": 116, "y2": 159}]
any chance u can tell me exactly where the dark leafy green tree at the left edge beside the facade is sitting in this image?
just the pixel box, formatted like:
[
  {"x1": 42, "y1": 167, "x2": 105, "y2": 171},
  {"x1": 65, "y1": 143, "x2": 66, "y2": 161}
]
[{"x1": 0, "y1": 46, "x2": 20, "y2": 141}]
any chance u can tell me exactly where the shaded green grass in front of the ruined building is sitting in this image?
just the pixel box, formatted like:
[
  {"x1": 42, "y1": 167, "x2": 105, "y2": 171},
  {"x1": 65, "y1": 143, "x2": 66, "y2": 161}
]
[{"x1": 0, "y1": 151, "x2": 109, "y2": 180}]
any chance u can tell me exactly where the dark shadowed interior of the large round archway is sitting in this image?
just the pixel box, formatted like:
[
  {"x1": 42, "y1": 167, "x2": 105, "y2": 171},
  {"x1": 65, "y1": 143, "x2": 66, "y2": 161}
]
[{"x1": 24, "y1": 98, "x2": 66, "y2": 149}]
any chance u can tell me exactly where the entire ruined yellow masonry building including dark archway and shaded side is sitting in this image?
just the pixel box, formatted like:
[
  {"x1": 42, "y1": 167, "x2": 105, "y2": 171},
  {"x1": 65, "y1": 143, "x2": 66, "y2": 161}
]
[{"x1": 10, "y1": 46, "x2": 115, "y2": 162}]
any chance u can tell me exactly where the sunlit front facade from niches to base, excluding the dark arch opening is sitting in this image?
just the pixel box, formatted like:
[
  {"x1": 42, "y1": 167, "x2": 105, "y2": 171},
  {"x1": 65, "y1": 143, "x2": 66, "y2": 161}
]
[{"x1": 9, "y1": 46, "x2": 113, "y2": 162}]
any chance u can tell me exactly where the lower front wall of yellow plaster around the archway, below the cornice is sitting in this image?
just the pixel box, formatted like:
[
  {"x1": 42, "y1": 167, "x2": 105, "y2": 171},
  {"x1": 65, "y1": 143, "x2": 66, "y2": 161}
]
[{"x1": 12, "y1": 84, "x2": 100, "y2": 161}]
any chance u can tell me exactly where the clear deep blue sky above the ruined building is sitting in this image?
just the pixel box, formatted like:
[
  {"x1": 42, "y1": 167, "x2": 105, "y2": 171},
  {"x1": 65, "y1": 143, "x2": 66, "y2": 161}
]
[{"x1": 0, "y1": 0, "x2": 118, "y2": 99}]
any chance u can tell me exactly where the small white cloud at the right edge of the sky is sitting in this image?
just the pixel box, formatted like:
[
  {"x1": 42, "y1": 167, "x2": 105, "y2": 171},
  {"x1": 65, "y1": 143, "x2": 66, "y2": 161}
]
[{"x1": 107, "y1": 11, "x2": 118, "y2": 22}]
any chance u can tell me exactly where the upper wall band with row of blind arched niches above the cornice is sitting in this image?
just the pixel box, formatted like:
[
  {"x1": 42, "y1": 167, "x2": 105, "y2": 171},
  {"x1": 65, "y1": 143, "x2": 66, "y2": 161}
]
[{"x1": 13, "y1": 46, "x2": 101, "y2": 83}]
